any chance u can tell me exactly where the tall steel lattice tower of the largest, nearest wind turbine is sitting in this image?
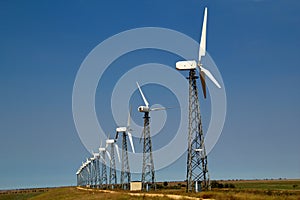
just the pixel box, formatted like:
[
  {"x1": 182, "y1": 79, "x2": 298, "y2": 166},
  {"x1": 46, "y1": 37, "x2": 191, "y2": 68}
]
[{"x1": 186, "y1": 69, "x2": 209, "y2": 192}]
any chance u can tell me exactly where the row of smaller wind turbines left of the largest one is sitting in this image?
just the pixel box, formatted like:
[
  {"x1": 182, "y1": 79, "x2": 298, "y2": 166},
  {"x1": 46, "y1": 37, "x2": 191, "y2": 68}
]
[{"x1": 76, "y1": 82, "x2": 159, "y2": 189}]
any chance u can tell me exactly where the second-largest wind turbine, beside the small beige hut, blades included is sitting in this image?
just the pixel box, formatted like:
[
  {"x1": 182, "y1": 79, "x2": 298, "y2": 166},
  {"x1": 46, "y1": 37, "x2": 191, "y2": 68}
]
[{"x1": 136, "y1": 82, "x2": 166, "y2": 190}]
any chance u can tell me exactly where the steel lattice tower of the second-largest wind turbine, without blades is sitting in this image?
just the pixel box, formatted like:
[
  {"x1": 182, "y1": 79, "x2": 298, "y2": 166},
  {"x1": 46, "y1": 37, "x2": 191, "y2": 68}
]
[{"x1": 142, "y1": 112, "x2": 156, "y2": 190}]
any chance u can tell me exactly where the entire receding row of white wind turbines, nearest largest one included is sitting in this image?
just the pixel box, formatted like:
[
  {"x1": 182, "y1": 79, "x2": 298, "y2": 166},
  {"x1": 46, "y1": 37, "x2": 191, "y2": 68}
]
[{"x1": 76, "y1": 8, "x2": 221, "y2": 192}]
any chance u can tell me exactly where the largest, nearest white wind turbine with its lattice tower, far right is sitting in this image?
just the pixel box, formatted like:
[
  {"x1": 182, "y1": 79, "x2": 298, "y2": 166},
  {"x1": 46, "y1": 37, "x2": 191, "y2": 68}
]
[{"x1": 176, "y1": 8, "x2": 221, "y2": 192}]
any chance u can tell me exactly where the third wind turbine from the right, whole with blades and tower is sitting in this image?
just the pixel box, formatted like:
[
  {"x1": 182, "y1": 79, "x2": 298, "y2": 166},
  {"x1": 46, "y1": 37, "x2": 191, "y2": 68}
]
[{"x1": 116, "y1": 107, "x2": 135, "y2": 189}]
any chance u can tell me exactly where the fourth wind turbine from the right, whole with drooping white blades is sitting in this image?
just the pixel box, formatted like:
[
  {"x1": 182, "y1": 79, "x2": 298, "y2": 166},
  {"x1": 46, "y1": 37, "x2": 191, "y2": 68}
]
[{"x1": 105, "y1": 135, "x2": 120, "y2": 189}]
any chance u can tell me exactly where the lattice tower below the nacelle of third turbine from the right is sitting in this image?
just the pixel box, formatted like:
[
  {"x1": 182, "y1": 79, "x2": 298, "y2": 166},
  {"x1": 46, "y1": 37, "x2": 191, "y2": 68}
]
[{"x1": 121, "y1": 132, "x2": 131, "y2": 190}]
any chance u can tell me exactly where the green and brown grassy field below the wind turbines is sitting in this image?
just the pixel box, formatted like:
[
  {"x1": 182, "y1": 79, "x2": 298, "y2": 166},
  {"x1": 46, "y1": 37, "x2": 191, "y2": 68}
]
[{"x1": 0, "y1": 180, "x2": 300, "y2": 200}]
